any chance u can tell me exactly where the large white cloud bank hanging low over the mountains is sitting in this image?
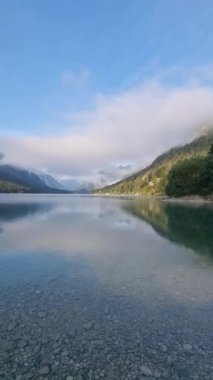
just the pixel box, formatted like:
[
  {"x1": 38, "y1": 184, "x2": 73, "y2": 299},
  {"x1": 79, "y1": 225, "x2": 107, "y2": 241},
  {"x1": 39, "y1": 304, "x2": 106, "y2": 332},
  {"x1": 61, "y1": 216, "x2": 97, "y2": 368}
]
[{"x1": 0, "y1": 81, "x2": 213, "y2": 181}]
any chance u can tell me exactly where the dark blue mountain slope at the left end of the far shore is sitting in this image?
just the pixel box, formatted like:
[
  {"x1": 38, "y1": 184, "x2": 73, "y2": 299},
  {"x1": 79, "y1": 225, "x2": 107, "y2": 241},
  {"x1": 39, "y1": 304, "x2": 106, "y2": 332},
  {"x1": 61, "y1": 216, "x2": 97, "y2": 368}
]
[{"x1": 0, "y1": 164, "x2": 68, "y2": 193}]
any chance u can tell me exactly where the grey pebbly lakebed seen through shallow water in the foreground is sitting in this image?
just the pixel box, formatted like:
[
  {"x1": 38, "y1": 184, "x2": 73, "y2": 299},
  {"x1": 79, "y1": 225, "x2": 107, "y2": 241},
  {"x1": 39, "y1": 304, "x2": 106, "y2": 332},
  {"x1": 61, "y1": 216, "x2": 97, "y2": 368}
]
[{"x1": 0, "y1": 274, "x2": 213, "y2": 380}]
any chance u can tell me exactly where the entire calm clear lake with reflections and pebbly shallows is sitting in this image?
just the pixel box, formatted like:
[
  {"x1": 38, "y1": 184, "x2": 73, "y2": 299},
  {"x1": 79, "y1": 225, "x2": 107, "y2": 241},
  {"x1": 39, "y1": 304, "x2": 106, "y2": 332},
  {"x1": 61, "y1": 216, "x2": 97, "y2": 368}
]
[{"x1": 0, "y1": 195, "x2": 213, "y2": 380}]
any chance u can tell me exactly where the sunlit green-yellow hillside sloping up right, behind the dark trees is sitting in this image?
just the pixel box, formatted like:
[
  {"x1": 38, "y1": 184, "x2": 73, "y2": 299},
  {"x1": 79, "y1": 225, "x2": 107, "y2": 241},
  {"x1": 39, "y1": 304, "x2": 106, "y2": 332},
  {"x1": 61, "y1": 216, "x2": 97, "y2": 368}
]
[{"x1": 96, "y1": 130, "x2": 213, "y2": 195}]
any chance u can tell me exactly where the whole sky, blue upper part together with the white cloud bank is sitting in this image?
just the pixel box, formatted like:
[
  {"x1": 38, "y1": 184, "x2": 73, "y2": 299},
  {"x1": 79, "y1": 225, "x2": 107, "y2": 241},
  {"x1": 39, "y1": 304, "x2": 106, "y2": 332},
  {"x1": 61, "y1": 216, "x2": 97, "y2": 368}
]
[{"x1": 0, "y1": 0, "x2": 213, "y2": 180}]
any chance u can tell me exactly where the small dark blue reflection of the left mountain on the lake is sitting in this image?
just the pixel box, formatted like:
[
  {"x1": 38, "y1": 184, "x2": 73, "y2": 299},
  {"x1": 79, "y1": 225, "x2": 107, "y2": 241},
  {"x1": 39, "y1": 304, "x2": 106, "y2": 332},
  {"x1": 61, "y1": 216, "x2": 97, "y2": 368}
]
[{"x1": 0, "y1": 203, "x2": 53, "y2": 222}]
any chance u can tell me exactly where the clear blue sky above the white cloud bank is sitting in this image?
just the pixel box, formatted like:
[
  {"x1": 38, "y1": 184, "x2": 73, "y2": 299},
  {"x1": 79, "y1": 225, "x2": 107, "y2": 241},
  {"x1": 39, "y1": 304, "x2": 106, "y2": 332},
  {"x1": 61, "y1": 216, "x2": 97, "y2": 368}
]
[{"x1": 0, "y1": 0, "x2": 213, "y2": 180}]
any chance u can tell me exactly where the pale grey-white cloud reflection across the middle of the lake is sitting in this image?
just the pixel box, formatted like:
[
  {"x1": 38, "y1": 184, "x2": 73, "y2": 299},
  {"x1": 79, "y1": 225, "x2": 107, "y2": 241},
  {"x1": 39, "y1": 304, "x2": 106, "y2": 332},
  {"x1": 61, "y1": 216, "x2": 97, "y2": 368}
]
[{"x1": 0, "y1": 197, "x2": 212, "y2": 304}]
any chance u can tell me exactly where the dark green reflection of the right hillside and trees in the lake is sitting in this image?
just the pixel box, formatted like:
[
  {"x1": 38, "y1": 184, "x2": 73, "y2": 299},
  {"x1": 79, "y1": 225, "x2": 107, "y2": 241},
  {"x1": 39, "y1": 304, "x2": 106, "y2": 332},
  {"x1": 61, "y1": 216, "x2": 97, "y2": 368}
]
[{"x1": 124, "y1": 198, "x2": 213, "y2": 256}]
